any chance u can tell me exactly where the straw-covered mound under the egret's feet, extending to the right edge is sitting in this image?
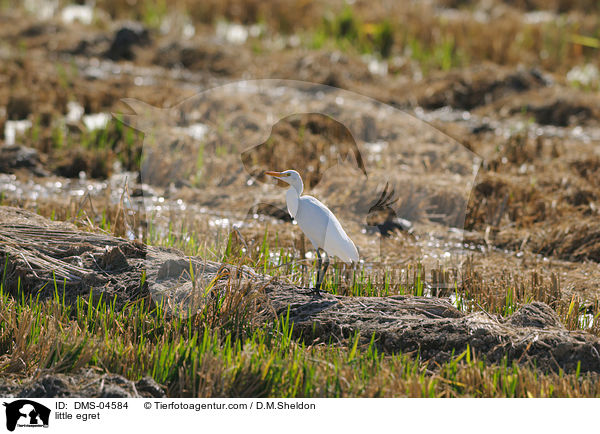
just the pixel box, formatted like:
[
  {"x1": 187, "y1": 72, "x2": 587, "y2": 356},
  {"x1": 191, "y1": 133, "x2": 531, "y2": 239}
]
[{"x1": 267, "y1": 287, "x2": 600, "y2": 372}]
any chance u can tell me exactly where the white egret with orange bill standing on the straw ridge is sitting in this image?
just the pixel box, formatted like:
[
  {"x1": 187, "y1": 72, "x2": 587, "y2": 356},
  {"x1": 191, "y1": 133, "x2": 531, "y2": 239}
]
[{"x1": 265, "y1": 170, "x2": 359, "y2": 296}]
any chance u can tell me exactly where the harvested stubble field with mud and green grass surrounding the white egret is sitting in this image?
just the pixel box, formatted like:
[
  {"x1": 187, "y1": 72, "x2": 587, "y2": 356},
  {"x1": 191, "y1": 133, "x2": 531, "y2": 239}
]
[{"x1": 0, "y1": 0, "x2": 600, "y2": 397}]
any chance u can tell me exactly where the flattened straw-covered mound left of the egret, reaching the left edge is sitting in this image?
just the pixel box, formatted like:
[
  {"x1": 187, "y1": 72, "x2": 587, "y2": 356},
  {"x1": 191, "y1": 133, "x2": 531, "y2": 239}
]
[{"x1": 0, "y1": 207, "x2": 249, "y2": 308}]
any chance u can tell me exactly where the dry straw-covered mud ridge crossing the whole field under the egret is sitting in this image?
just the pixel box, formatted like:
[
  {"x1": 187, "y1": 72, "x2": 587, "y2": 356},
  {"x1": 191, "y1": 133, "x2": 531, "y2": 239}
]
[{"x1": 0, "y1": 203, "x2": 600, "y2": 390}]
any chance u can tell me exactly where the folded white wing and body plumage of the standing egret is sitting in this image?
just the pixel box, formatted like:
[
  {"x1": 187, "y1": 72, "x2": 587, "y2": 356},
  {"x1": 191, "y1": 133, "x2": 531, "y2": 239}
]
[{"x1": 296, "y1": 196, "x2": 358, "y2": 262}]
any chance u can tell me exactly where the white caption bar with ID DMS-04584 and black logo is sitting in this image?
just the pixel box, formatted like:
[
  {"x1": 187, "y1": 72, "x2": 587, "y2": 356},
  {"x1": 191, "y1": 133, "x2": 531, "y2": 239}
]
[{"x1": 0, "y1": 398, "x2": 600, "y2": 434}]
